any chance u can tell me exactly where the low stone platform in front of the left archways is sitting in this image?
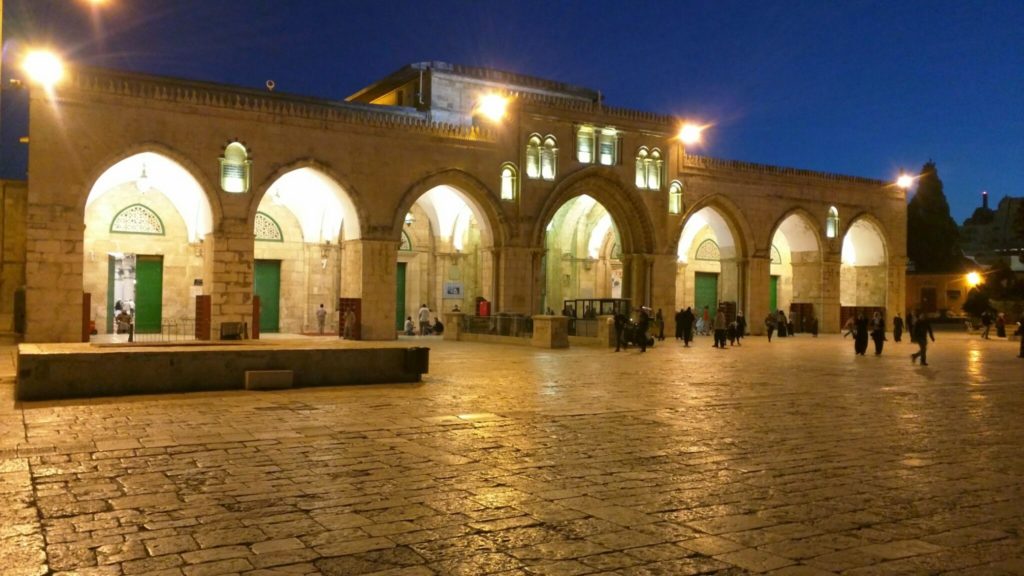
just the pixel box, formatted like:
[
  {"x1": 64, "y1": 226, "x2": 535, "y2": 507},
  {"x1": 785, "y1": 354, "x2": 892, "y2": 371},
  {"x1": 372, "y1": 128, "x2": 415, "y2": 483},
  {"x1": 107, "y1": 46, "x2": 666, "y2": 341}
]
[{"x1": 15, "y1": 340, "x2": 430, "y2": 401}]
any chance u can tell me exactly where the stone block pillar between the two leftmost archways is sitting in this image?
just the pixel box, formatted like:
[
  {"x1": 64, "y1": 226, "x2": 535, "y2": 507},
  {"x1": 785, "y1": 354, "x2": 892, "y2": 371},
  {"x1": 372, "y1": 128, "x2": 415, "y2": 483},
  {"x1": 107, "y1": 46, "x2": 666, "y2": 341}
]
[{"x1": 204, "y1": 217, "x2": 255, "y2": 334}]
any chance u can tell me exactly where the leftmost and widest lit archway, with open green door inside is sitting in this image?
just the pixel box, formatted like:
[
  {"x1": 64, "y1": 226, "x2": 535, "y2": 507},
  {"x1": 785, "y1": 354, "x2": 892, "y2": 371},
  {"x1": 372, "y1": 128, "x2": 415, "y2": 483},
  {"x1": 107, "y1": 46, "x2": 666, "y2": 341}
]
[{"x1": 83, "y1": 152, "x2": 213, "y2": 334}]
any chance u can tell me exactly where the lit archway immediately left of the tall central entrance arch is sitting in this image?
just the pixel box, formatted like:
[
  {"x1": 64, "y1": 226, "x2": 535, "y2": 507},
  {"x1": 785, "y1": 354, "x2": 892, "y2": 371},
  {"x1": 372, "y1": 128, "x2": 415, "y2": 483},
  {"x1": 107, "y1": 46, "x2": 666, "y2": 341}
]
[{"x1": 395, "y1": 183, "x2": 494, "y2": 330}]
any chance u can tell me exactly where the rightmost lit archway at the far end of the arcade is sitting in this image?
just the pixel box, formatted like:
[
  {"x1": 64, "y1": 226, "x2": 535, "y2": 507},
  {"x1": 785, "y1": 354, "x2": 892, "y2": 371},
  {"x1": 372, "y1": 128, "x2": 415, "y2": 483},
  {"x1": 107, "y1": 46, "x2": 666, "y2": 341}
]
[{"x1": 840, "y1": 217, "x2": 889, "y2": 326}]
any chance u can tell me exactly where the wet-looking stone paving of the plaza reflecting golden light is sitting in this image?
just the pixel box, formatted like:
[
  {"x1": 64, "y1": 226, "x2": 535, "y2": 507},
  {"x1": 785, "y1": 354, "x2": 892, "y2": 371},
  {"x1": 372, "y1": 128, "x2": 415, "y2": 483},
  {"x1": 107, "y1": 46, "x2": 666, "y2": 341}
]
[{"x1": 0, "y1": 333, "x2": 1024, "y2": 576}]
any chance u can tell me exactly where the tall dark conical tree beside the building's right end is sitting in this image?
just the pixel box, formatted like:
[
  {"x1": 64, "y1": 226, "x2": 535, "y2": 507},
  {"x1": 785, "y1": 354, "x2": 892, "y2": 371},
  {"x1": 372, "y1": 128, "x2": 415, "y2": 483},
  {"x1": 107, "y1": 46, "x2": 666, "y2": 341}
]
[{"x1": 906, "y1": 160, "x2": 963, "y2": 274}]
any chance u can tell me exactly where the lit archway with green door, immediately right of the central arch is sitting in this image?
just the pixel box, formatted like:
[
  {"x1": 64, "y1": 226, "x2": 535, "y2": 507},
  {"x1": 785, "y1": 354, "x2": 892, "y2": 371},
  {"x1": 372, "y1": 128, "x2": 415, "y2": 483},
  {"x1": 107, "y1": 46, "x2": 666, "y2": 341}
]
[{"x1": 675, "y1": 206, "x2": 742, "y2": 321}]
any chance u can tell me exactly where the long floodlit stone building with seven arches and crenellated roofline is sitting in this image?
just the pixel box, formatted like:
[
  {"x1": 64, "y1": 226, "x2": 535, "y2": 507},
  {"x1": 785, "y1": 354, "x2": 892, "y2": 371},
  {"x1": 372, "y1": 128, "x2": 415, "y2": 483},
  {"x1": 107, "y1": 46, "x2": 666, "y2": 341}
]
[{"x1": 9, "y1": 63, "x2": 906, "y2": 341}]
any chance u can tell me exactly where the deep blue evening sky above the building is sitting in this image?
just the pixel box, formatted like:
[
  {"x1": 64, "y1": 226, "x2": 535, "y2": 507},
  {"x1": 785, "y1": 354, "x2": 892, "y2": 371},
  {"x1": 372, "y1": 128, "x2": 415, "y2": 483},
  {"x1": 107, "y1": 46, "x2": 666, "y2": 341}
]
[{"x1": 0, "y1": 0, "x2": 1024, "y2": 222}]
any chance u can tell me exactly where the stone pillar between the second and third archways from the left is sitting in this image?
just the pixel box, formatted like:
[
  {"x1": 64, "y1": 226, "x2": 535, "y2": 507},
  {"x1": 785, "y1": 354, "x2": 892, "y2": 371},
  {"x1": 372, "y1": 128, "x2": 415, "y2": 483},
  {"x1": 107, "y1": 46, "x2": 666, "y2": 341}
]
[{"x1": 341, "y1": 239, "x2": 398, "y2": 340}]
